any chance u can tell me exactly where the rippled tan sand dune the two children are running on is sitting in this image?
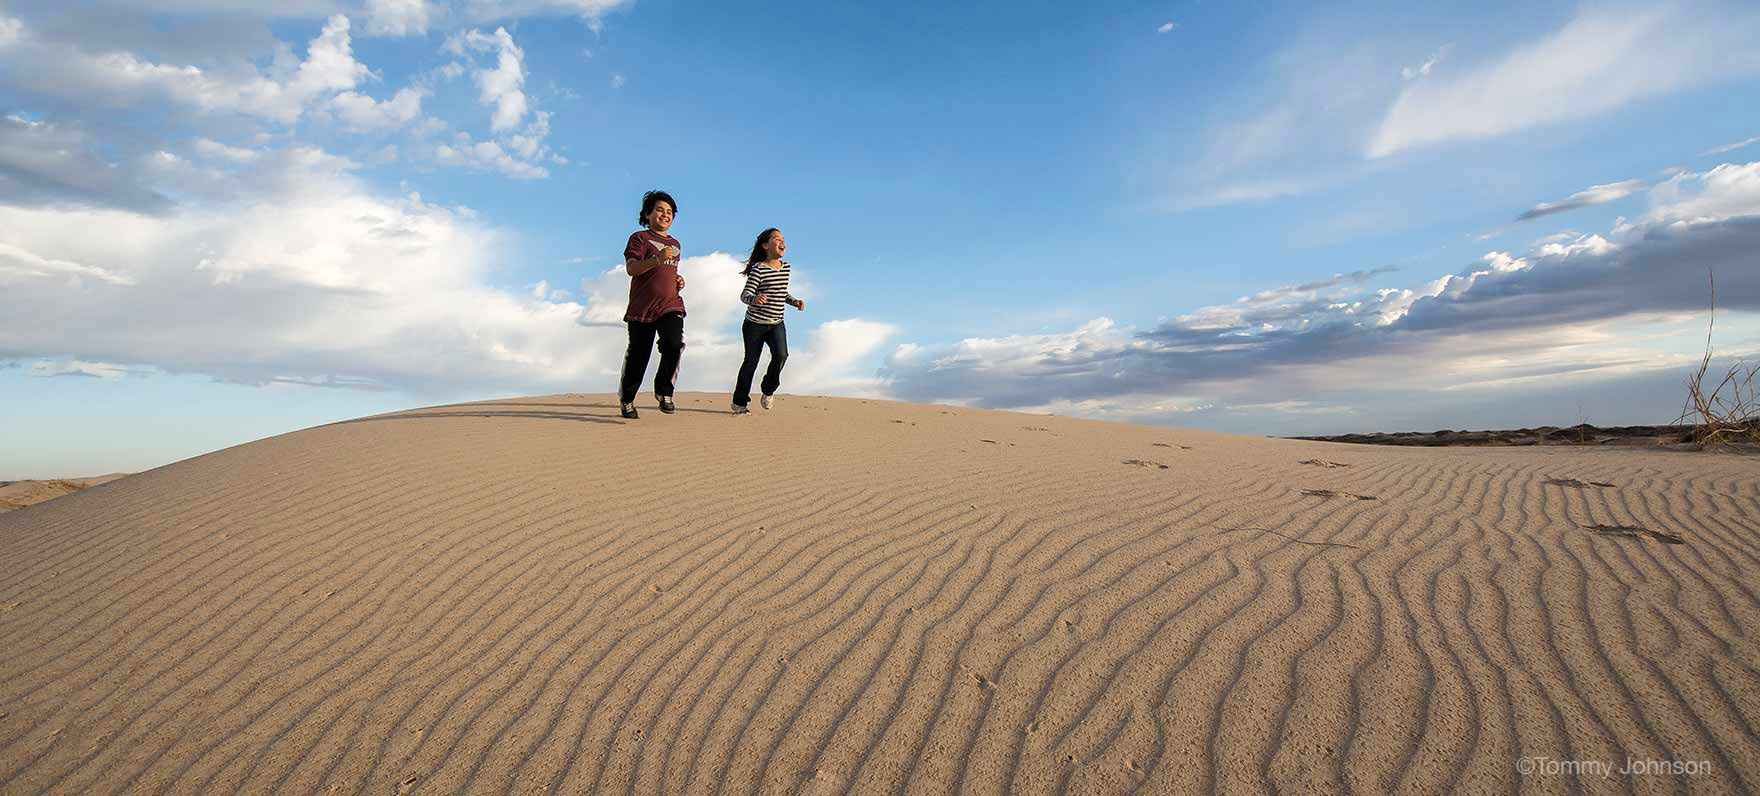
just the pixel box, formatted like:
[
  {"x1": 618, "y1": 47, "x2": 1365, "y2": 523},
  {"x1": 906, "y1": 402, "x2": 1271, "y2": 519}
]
[{"x1": 0, "y1": 393, "x2": 1760, "y2": 796}]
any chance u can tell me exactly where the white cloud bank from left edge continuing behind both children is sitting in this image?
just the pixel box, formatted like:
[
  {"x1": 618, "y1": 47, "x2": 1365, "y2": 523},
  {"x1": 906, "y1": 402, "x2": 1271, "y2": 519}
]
[{"x1": 0, "y1": 143, "x2": 884, "y2": 394}]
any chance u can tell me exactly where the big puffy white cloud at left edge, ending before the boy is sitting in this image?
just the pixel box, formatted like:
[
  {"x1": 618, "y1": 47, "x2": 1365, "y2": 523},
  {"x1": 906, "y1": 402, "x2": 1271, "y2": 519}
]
[{"x1": 0, "y1": 150, "x2": 591, "y2": 389}]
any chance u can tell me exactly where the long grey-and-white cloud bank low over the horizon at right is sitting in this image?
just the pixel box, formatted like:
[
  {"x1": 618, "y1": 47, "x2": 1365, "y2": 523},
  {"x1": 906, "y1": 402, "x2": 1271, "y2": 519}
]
[{"x1": 884, "y1": 162, "x2": 1760, "y2": 417}]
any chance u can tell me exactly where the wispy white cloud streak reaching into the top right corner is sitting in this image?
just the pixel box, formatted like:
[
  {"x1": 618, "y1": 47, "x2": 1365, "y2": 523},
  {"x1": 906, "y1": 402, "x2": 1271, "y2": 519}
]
[{"x1": 1368, "y1": 4, "x2": 1760, "y2": 157}]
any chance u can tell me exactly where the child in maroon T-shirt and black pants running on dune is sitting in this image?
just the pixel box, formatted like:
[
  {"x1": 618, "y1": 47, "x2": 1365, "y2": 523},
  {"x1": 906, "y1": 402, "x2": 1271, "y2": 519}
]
[{"x1": 618, "y1": 190, "x2": 685, "y2": 419}]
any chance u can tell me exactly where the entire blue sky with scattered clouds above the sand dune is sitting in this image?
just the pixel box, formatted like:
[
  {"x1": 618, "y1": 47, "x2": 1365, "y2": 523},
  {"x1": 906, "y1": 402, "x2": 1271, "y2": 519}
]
[{"x1": 0, "y1": 0, "x2": 1760, "y2": 479}]
